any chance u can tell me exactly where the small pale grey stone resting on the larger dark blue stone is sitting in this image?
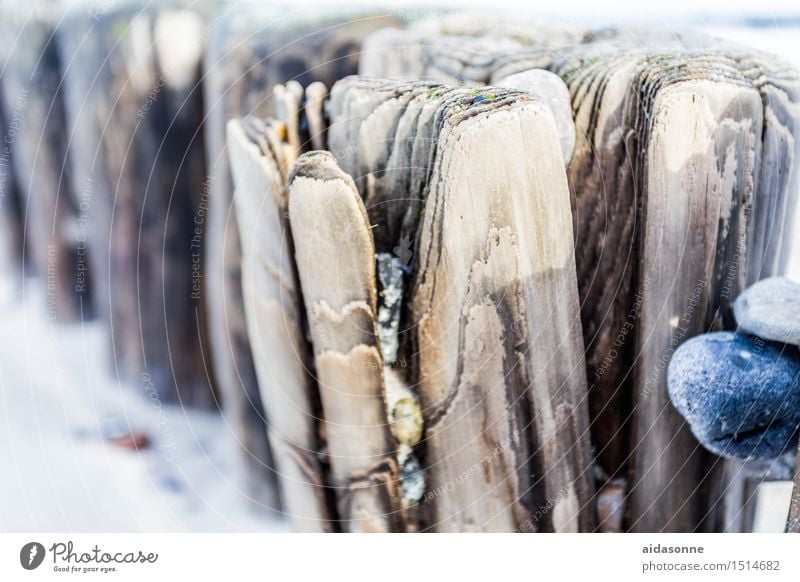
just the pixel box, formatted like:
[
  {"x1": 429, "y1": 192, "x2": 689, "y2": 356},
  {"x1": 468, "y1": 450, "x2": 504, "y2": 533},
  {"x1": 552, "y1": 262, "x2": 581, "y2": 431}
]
[{"x1": 733, "y1": 277, "x2": 800, "y2": 346}]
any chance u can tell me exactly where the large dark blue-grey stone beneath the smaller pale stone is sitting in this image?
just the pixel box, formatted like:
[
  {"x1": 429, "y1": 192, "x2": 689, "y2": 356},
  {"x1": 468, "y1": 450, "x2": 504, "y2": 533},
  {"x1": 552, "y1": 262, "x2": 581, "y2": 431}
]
[{"x1": 667, "y1": 332, "x2": 800, "y2": 460}]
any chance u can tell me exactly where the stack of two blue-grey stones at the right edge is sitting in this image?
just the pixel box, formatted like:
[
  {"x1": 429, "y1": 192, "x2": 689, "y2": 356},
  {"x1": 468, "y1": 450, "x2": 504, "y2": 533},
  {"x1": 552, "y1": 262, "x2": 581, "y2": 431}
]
[{"x1": 667, "y1": 277, "x2": 800, "y2": 479}]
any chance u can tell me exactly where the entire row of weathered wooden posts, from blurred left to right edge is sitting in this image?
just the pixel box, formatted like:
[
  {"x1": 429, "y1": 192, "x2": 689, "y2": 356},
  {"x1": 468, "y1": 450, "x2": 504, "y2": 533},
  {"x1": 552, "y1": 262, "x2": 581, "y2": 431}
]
[{"x1": 0, "y1": 2, "x2": 800, "y2": 531}]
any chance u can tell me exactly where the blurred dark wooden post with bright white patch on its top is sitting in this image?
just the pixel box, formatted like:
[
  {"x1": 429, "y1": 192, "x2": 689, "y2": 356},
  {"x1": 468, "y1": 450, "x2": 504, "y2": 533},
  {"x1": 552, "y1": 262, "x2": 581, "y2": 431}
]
[{"x1": 59, "y1": 3, "x2": 214, "y2": 406}]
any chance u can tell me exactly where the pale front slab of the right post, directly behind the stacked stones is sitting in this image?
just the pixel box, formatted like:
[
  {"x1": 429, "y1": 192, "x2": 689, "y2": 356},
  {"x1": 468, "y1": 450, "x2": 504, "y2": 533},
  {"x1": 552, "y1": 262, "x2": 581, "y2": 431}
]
[{"x1": 628, "y1": 80, "x2": 762, "y2": 531}]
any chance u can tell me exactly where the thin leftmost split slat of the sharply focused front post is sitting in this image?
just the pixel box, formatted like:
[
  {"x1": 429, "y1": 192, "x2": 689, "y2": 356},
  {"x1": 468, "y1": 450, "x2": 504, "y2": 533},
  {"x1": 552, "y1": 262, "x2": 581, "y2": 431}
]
[{"x1": 227, "y1": 117, "x2": 335, "y2": 532}]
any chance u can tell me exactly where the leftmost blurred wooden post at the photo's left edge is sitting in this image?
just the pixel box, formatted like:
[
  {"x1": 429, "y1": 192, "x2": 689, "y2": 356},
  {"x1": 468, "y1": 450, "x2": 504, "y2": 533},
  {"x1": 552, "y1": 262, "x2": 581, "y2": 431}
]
[{"x1": 0, "y1": 3, "x2": 87, "y2": 322}]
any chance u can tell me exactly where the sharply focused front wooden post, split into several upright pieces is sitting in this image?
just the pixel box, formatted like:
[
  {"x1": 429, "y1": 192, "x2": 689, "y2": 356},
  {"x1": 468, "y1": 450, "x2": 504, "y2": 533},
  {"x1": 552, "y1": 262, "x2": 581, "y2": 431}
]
[{"x1": 228, "y1": 77, "x2": 594, "y2": 531}]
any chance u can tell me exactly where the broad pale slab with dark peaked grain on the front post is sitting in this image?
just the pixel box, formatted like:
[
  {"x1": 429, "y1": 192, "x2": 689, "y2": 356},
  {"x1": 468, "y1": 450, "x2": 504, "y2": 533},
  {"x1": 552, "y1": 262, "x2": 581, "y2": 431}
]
[{"x1": 411, "y1": 88, "x2": 594, "y2": 531}]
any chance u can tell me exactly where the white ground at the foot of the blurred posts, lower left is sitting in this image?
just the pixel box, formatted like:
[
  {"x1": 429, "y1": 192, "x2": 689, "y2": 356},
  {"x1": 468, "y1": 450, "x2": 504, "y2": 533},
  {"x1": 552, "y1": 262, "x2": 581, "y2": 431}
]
[{"x1": 0, "y1": 282, "x2": 287, "y2": 532}]
